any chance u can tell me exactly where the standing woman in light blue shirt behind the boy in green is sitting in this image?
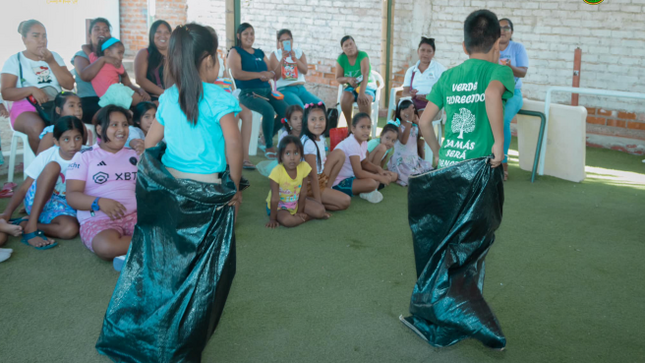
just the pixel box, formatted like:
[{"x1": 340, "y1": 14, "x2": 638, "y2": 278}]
[{"x1": 499, "y1": 18, "x2": 529, "y2": 180}]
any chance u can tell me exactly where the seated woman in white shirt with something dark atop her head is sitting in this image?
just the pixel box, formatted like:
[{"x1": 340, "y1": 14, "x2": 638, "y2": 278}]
[{"x1": 403, "y1": 37, "x2": 446, "y2": 111}]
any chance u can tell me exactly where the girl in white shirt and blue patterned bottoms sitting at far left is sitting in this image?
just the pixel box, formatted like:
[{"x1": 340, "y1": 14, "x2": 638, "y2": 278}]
[{"x1": 0, "y1": 116, "x2": 84, "y2": 250}]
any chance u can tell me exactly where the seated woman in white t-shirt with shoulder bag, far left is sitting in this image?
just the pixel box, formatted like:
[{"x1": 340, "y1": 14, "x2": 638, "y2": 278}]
[{"x1": 0, "y1": 19, "x2": 74, "y2": 153}]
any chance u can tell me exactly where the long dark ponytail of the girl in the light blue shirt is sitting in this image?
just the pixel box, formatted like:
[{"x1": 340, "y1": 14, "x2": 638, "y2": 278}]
[{"x1": 165, "y1": 23, "x2": 219, "y2": 125}]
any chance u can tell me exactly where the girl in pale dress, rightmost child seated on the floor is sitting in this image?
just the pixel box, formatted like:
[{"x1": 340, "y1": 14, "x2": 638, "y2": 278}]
[{"x1": 387, "y1": 100, "x2": 433, "y2": 187}]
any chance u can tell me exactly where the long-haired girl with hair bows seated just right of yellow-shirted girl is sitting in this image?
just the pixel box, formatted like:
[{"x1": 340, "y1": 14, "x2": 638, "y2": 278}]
[{"x1": 300, "y1": 102, "x2": 352, "y2": 210}]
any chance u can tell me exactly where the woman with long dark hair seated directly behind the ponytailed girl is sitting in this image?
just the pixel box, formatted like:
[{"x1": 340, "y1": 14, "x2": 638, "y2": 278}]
[{"x1": 134, "y1": 20, "x2": 172, "y2": 101}]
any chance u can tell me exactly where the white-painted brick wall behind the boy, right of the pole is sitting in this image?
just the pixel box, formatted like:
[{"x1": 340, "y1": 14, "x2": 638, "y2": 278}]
[{"x1": 393, "y1": 0, "x2": 645, "y2": 139}]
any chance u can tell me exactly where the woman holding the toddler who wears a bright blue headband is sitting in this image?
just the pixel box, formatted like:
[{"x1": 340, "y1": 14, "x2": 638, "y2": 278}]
[{"x1": 72, "y1": 18, "x2": 112, "y2": 124}]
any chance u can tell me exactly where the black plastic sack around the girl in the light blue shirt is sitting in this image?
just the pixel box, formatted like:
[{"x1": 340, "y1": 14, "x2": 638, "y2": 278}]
[{"x1": 96, "y1": 146, "x2": 248, "y2": 363}]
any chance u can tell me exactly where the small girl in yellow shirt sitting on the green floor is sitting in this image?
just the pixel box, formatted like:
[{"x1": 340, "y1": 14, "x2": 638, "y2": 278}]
[{"x1": 266, "y1": 135, "x2": 330, "y2": 228}]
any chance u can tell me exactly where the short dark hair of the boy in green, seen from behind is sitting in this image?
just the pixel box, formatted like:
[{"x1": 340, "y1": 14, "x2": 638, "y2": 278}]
[{"x1": 464, "y1": 10, "x2": 502, "y2": 54}]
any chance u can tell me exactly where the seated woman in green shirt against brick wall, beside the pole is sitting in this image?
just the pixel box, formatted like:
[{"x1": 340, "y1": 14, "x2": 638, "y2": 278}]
[{"x1": 336, "y1": 35, "x2": 376, "y2": 125}]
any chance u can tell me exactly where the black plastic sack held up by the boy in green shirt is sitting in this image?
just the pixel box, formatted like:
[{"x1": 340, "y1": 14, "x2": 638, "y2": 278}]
[{"x1": 401, "y1": 158, "x2": 506, "y2": 349}]
